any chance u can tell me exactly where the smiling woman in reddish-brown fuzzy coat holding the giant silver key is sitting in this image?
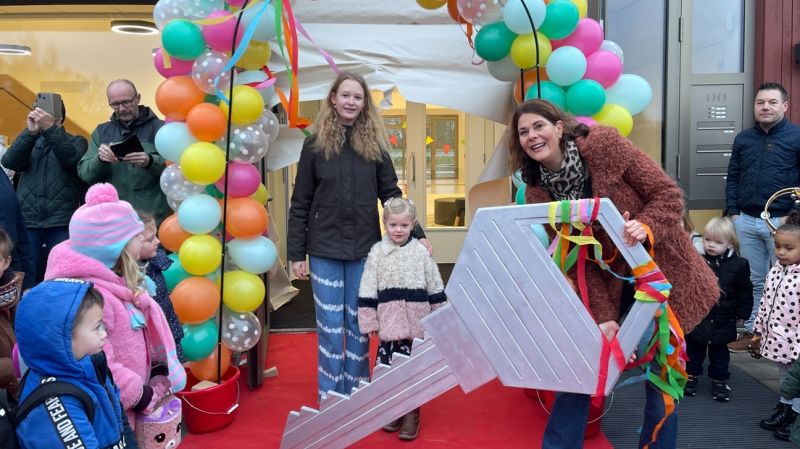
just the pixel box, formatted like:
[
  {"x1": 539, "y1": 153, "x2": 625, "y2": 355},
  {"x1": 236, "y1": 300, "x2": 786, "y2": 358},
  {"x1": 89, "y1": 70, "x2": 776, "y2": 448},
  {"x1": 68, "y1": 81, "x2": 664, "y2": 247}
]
[{"x1": 509, "y1": 100, "x2": 719, "y2": 449}]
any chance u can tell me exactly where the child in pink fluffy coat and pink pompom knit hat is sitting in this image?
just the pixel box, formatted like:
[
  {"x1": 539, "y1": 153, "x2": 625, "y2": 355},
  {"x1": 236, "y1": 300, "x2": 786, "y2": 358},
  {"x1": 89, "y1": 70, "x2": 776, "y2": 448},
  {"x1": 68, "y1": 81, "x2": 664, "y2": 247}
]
[{"x1": 45, "y1": 183, "x2": 186, "y2": 438}]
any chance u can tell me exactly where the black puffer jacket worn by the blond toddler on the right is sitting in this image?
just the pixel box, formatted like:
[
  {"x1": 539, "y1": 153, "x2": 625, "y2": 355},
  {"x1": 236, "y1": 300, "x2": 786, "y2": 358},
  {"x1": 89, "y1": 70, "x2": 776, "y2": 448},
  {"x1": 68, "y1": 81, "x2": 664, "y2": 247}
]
[{"x1": 688, "y1": 250, "x2": 753, "y2": 345}]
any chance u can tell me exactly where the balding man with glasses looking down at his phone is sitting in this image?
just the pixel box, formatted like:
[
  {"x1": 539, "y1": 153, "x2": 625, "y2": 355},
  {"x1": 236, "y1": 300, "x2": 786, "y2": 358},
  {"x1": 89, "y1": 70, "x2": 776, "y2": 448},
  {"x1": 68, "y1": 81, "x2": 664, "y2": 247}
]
[{"x1": 78, "y1": 79, "x2": 169, "y2": 225}]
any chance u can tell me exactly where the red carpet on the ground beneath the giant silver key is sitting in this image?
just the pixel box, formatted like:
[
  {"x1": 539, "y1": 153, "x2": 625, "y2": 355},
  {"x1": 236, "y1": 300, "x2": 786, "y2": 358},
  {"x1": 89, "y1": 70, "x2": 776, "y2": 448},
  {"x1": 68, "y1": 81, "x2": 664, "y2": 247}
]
[{"x1": 181, "y1": 333, "x2": 613, "y2": 449}]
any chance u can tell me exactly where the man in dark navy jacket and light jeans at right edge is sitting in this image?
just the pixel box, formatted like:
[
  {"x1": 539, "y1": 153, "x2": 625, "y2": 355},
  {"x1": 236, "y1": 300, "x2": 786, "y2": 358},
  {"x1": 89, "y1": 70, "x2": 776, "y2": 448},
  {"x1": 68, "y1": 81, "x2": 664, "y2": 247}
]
[{"x1": 725, "y1": 83, "x2": 800, "y2": 352}]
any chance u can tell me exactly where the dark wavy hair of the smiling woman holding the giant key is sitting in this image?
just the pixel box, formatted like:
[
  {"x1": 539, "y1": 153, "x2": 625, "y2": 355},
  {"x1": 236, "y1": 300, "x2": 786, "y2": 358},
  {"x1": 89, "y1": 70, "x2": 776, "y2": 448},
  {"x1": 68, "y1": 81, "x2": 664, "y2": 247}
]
[{"x1": 508, "y1": 99, "x2": 589, "y2": 185}]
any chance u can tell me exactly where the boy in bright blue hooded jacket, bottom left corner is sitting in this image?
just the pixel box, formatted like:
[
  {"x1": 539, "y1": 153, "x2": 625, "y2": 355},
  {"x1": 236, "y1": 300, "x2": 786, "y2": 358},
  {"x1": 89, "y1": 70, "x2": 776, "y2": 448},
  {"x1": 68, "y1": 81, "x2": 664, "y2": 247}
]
[{"x1": 16, "y1": 279, "x2": 137, "y2": 449}]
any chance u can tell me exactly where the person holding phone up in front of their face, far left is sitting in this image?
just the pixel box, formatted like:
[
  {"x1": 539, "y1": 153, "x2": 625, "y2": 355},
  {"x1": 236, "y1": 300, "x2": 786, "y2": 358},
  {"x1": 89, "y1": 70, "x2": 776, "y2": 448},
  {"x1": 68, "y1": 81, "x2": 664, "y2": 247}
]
[{"x1": 0, "y1": 94, "x2": 87, "y2": 286}]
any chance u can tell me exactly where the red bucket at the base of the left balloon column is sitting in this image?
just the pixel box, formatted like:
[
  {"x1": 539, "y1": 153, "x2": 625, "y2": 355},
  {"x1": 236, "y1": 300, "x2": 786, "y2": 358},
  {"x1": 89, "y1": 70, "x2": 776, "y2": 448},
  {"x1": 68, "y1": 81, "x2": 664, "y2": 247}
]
[{"x1": 176, "y1": 366, "x2": 239, "y2": 433}]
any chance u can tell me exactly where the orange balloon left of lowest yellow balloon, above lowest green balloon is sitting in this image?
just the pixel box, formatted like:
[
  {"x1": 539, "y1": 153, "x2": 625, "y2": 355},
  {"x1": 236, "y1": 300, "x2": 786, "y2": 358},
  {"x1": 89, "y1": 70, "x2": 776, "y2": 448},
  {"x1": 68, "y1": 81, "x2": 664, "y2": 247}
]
[{"x1": 169, "y1": 276, "x2": 220, "y2": 324}]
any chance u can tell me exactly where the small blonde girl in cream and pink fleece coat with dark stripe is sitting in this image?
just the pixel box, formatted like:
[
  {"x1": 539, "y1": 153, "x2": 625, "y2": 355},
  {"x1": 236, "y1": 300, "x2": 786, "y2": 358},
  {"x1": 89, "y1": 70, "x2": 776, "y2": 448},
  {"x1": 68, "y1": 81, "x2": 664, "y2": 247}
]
[{"x1": 358, "y1": 198, "x2": 446, "y2": 440}]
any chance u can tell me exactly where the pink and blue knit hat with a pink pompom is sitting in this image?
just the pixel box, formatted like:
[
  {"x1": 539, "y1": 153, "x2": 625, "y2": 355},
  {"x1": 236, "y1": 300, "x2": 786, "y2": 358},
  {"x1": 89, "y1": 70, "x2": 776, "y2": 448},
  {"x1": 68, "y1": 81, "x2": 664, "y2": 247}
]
[{"x1": 69, "y1": 183, "x2": 144, "y2": 268}]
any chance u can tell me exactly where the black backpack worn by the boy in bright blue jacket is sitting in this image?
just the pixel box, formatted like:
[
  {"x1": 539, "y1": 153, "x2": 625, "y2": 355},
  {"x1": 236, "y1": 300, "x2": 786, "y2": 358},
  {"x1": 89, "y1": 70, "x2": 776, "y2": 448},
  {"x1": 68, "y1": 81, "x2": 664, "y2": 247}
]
[{"x1": 0, "y1": 378, "x2": 94, "y2": 449}]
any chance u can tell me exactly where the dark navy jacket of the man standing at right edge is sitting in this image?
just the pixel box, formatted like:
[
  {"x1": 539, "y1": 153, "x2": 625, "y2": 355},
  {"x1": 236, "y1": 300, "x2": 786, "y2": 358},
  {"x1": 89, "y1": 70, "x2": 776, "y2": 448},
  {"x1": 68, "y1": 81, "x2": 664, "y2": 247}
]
[{"x1": 725, "y1": 118, "x2": 800, "y2": 217}]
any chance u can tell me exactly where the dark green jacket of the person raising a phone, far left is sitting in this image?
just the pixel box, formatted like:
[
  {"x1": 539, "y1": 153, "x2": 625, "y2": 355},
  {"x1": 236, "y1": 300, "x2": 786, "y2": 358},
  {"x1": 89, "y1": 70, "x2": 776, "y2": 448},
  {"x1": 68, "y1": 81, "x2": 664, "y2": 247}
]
[{"x1": 2, "y1": 126, "x2": 88, "y2": 228}]
